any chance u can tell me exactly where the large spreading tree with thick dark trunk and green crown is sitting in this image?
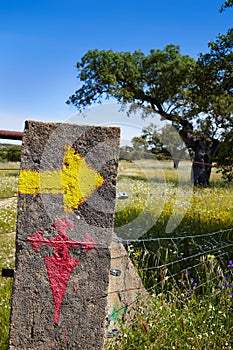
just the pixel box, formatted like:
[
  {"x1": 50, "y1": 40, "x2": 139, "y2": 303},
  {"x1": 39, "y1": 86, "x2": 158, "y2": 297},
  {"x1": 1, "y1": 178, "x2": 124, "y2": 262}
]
[{"x1": 67, "y1": 36, "x2": 232, "y2": 186}]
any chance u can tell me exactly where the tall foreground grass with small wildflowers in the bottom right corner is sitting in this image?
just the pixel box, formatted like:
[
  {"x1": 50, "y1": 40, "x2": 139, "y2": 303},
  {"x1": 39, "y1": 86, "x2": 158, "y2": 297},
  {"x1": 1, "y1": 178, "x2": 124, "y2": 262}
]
[{"x1": 105, "y1": 255, "x2": 233, "y2": 350}]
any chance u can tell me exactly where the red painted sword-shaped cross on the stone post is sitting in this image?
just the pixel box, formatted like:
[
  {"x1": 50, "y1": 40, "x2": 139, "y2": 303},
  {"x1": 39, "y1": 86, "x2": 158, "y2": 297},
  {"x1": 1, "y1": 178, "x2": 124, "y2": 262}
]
[{"x1": 28, "y1": 218, "x2": 96, "y2": 323}]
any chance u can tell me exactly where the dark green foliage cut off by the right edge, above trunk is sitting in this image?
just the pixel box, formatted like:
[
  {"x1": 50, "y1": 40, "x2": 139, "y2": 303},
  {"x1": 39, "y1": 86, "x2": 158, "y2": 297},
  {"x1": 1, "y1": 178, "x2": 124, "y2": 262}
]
[{"x1": 191, "y1": 28, "x2": 233, "y2": 137}]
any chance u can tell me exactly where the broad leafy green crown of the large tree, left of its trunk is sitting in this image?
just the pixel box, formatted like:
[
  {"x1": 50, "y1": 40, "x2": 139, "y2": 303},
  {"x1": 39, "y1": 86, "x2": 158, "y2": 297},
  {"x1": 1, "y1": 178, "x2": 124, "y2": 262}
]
[{"x1": 68, "y1": 45, "x2": 195, "y2": 120}]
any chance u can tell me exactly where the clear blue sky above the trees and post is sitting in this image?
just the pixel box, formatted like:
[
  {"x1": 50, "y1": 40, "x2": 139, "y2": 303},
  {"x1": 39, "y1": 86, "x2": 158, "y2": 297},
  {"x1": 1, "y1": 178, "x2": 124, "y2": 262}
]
[{"x1": 0, "y1": 0, "x2": 233, "y2": 141}]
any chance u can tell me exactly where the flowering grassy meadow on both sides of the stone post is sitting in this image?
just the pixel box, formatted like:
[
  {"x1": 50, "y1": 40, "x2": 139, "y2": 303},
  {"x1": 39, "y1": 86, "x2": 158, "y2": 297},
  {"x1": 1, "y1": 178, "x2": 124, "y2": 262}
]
[{"x1": 0, "y1": 160, "x2": 233, "y2": 350}]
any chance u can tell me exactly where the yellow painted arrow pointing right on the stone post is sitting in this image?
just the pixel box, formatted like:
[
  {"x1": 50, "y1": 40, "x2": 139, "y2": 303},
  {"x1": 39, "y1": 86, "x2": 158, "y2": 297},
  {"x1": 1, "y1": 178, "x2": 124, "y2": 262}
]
[{"x1": 19, "y1": 146, "x2": 104, "y2": 213}]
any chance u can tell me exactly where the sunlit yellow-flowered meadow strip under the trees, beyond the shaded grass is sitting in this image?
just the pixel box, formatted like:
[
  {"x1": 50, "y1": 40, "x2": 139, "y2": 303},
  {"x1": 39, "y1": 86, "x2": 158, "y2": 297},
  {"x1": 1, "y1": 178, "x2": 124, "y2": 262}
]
[{"x1": 115, "y1": 161, "x2": 233, "y2": 238}]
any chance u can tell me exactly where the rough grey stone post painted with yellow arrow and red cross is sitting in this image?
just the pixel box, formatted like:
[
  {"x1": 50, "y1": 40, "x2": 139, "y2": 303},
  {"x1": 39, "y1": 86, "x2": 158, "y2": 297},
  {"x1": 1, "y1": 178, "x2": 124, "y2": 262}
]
[{"x1": 9, "y1": 121, "x2": 120, "y2": 350}]
